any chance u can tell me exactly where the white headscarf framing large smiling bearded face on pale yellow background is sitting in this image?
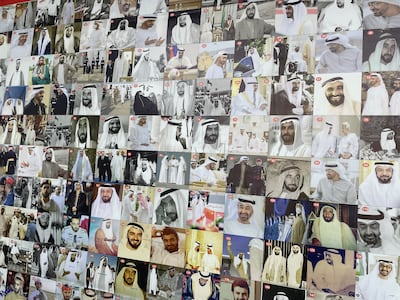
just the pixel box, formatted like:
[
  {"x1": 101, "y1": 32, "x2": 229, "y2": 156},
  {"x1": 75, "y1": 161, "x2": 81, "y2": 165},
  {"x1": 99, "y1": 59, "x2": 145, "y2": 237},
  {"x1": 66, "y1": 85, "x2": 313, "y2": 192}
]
[{"x1": 314, "y1": 76, "x2": 360, "y2": 115}]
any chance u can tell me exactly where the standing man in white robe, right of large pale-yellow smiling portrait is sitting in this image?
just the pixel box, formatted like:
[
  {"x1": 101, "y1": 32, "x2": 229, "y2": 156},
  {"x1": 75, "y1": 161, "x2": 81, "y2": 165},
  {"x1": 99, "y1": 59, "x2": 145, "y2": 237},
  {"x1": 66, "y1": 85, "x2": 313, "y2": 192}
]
[{"x1": 362, "y1": 73, "x2": 390, "y2": 116}]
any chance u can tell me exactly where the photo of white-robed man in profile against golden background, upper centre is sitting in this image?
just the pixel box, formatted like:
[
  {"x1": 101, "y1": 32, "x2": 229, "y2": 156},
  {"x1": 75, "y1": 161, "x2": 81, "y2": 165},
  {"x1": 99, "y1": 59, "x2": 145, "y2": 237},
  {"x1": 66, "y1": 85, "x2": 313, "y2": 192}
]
[{"x1": 197, "y1": 41, "x2": 235, "y2": 79}]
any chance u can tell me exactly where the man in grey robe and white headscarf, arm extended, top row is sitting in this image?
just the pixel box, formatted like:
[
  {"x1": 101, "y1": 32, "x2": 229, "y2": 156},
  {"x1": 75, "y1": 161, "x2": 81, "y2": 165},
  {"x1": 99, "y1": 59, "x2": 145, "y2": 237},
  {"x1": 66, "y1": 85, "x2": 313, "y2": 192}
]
[{"x1": 235, "y1": 2, "x2": 275, "y2": 40}]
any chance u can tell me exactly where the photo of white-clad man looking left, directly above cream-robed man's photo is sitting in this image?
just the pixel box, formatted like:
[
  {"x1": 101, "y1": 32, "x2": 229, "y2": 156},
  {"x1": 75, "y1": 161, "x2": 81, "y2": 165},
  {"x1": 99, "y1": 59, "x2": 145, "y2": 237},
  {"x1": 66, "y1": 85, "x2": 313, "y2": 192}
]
[{"x1": 310, "y1": 158, "x2": 360, "y2": 205}]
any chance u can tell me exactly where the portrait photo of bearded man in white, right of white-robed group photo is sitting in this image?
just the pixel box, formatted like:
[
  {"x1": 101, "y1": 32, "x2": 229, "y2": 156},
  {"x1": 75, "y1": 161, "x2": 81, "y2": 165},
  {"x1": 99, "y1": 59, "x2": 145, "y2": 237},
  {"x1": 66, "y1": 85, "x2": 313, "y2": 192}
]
[{"x1": 268, "y1": 116, "x2": 312, "y2": 158}]
